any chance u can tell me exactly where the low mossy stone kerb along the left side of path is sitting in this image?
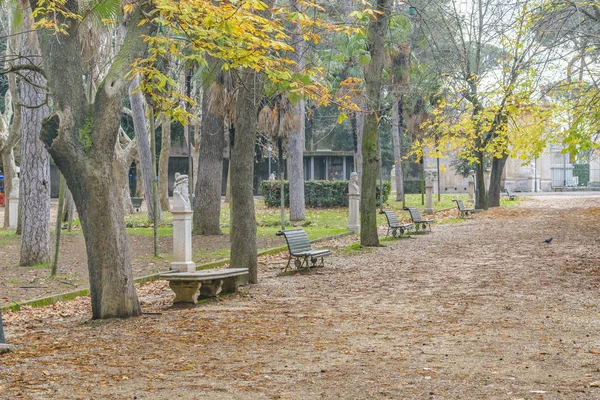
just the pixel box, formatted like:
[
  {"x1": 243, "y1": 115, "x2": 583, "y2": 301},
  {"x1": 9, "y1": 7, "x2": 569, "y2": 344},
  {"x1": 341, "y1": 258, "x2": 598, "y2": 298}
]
[{"x1": 2, "y1": 232, "x2": 352, "y2": 311}]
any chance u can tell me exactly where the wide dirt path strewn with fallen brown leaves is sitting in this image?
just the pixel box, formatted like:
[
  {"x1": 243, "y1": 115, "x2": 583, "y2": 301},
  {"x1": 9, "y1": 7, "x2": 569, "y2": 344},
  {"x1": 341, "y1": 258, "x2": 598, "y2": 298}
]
[{"x1": 0, "y1": 196, "x2": 600, "y2": 400}]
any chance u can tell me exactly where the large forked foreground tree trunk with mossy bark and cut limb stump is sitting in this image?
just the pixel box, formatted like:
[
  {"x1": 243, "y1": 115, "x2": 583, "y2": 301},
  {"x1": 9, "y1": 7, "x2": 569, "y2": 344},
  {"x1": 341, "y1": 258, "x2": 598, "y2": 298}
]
[{"x1": 31, "y1": 0, "x2": 153, "y2": 319}]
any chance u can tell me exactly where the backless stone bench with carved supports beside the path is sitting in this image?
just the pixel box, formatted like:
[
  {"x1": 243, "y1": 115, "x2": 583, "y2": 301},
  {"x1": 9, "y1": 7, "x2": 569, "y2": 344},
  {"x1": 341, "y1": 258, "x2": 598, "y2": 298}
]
[{"x1": 160, "y1": 268, "x2": 248, "y2": 304}]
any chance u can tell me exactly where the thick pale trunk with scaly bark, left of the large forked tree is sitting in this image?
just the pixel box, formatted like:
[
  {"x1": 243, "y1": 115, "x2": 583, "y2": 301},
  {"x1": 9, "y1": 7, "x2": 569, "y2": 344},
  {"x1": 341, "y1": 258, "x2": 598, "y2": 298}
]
[{"x1": 19, "y1": 14, "x2": 50, "y2": 266}]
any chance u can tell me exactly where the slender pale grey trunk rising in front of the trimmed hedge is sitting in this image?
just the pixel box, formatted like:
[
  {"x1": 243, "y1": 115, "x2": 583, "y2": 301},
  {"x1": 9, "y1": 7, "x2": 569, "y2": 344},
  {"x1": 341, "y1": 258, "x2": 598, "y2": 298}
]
[{"x1": 287, "y1": 0, "x2": 308, "y2": 221}]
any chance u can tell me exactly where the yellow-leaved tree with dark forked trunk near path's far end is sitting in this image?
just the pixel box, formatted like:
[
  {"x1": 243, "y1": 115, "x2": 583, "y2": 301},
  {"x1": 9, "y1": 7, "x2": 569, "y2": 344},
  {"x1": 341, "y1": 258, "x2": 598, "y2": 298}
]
[{"x1": 417, "y1": 0, "x2": 547, "y2": 209}]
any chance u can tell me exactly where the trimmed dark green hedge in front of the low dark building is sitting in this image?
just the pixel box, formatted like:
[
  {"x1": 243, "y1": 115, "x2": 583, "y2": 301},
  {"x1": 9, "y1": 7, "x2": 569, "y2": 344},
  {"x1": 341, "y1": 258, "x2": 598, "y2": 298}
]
[{"x1": 260, "y1": 180, "x2": 391, "y2": 208}]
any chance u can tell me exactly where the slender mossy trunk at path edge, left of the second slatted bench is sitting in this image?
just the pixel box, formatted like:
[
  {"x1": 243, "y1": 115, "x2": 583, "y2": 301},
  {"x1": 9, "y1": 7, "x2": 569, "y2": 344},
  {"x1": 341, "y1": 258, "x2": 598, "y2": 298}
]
[{"x1": 360, "y1": 0, "x2": 391, "y2": 246}]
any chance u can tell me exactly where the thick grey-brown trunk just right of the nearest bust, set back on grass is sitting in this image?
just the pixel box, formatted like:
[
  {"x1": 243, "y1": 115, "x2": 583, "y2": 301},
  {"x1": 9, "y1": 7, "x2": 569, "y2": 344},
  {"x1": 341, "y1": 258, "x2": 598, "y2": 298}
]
[{"x1": 192, "y1": 67, "x2": 225, "y2": 235}]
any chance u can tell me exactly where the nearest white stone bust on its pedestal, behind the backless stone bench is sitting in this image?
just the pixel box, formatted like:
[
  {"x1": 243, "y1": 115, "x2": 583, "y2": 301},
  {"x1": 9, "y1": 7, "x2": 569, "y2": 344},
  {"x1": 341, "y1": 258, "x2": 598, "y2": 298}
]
[{"x1": 171, "y1": 174, "x2": 197, "y2": 274}]
